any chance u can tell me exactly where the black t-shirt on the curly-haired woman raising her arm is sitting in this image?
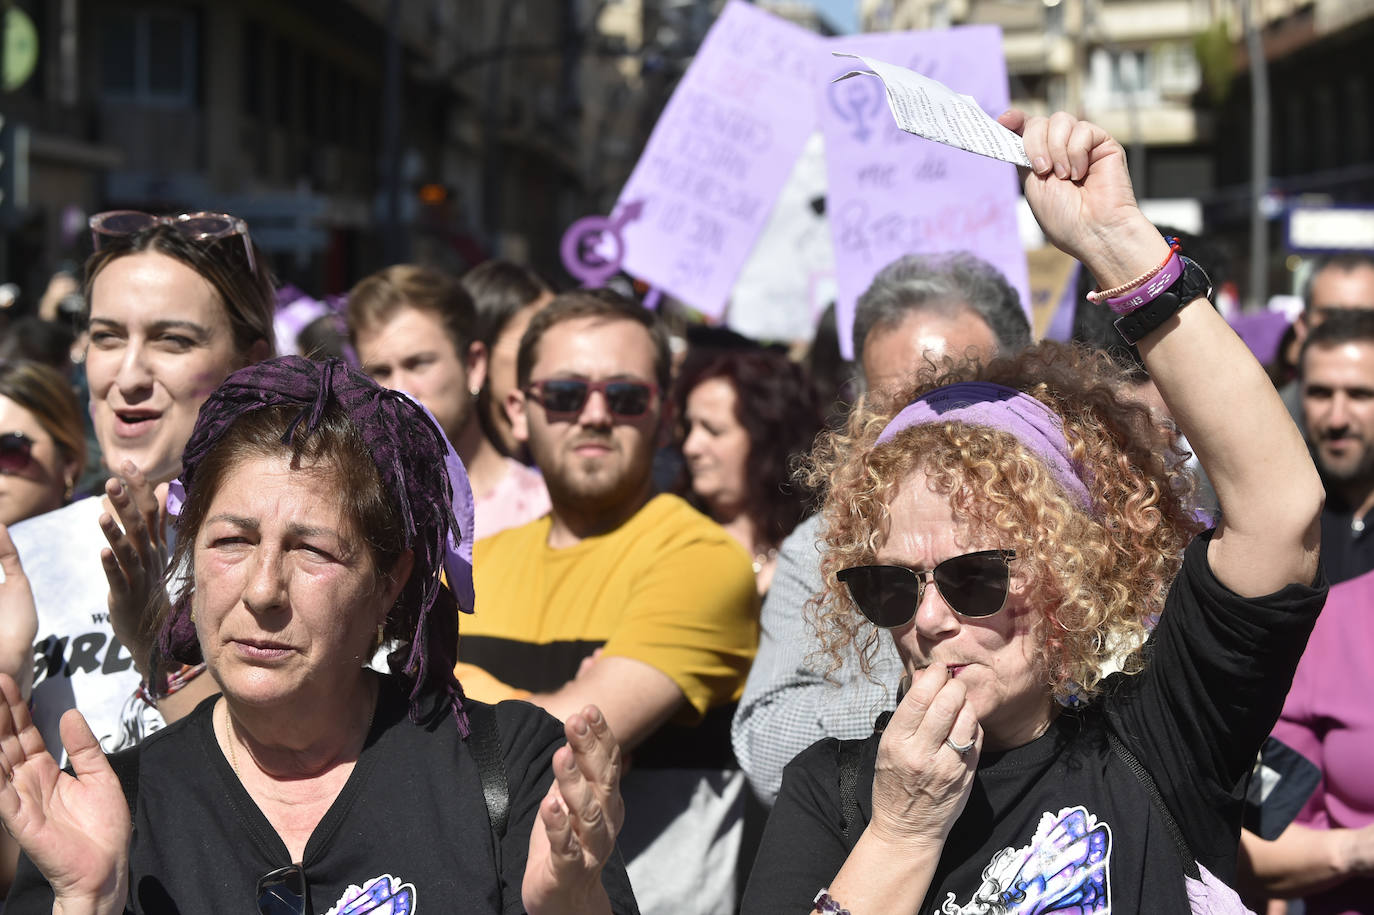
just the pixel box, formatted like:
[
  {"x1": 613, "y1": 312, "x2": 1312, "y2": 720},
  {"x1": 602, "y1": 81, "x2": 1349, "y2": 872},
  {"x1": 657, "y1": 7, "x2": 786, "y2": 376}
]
[{"x1": 743, "y1": 536, "x2": 1326, "y2": 915}]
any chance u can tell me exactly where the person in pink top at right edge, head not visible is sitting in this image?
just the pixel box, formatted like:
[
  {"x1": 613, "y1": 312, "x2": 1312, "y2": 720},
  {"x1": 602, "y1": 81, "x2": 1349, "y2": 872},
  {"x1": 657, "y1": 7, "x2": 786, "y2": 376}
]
[{"x1": 1242, "y1": 572, "x2": 1374, "y2": 915}]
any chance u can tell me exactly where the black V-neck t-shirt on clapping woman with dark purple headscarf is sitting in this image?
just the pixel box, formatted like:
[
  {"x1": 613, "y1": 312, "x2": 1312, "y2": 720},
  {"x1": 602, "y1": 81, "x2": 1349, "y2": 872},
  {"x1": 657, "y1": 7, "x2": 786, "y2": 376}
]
[{"x1": 5, "y1": 677, "x2": 638, "y2": 915}]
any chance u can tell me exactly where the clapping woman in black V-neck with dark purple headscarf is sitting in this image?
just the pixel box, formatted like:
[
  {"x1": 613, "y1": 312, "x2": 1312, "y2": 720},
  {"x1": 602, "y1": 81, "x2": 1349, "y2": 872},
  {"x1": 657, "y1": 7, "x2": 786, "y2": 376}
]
[{"x1": 0, "y1": 357, "x2": 636, "y2": 915}]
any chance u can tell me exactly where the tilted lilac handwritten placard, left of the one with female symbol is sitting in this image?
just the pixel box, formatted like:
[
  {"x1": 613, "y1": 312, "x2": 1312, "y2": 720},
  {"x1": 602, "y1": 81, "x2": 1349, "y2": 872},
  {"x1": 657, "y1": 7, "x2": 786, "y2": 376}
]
[{"x1": 617, "y1": 0, "x2": 822, "y2": 317}]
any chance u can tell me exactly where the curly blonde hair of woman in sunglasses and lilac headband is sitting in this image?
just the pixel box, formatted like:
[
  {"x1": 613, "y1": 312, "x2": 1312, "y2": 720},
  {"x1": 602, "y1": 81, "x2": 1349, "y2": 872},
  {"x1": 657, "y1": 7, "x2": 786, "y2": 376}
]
[{"x1": 800, "y1": 337, "x2": 1202, "y2": 701}]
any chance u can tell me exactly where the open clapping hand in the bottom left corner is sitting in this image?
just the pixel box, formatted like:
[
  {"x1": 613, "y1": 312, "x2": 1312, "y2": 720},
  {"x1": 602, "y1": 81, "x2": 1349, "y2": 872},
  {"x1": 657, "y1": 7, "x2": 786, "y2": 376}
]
[{"x1": 0, "y1": 675, "x2": 132, "y2": 912}]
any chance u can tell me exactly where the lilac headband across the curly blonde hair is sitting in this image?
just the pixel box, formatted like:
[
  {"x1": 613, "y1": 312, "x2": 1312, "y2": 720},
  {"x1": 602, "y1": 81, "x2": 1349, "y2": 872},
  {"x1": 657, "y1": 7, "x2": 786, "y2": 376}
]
[{"x1": 877, "y1": 382, "x2": 1092, "y2": 505}]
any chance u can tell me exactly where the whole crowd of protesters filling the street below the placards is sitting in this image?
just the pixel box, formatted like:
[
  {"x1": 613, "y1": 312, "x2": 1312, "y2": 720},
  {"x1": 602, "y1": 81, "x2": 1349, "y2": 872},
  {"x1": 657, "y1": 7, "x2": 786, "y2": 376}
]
[{"x1": 0, "y1": 113, "x2": 1374, "y2": 915}]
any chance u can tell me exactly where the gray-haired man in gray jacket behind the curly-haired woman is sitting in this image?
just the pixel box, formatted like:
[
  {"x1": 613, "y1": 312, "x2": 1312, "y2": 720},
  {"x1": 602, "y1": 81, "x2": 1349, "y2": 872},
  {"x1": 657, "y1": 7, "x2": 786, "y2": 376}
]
[{"x1": 731, "y1": 254, "x2": 1031, "y2": 805}]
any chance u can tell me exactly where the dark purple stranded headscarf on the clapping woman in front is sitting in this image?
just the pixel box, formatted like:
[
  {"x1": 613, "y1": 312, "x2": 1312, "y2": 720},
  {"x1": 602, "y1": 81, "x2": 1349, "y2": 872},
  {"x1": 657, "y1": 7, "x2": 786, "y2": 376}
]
[{"x1": 158, "y1": 356, "x2": 474, "y2": 736}]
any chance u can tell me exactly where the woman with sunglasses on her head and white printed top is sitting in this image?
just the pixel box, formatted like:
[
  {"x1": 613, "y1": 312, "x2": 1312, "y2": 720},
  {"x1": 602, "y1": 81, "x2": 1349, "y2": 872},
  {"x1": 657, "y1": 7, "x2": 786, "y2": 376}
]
[{"x1": 0, "y1": 210, "x2": 275, "y2": 752}]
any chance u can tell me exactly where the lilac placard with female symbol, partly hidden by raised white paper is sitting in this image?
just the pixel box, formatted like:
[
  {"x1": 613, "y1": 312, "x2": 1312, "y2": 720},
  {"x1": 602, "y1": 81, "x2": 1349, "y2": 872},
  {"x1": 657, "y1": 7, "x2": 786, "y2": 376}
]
[{"x1": 816, "y1": 26, "x2": 1031, "y2": 356}]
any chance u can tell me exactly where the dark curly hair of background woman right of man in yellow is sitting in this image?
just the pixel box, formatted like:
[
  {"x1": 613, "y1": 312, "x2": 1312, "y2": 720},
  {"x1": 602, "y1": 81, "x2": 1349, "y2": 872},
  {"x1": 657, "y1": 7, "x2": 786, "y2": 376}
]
[{"x1": 673, "y1": 349, "x2": 824, "y2": 548}]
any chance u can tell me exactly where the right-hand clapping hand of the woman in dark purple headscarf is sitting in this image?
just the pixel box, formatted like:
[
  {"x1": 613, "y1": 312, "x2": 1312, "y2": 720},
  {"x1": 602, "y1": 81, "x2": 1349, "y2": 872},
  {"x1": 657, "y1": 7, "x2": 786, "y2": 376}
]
[{"x1": 521, "y1": 705, "x2": 625, "y2": 915}]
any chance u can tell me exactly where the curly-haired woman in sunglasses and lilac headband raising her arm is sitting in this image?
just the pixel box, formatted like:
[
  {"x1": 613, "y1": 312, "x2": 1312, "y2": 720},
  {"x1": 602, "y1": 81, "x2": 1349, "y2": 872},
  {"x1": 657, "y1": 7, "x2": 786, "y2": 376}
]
[{"x1": 743, "y1": 111, "x2": 1326, "y2": 915}]
